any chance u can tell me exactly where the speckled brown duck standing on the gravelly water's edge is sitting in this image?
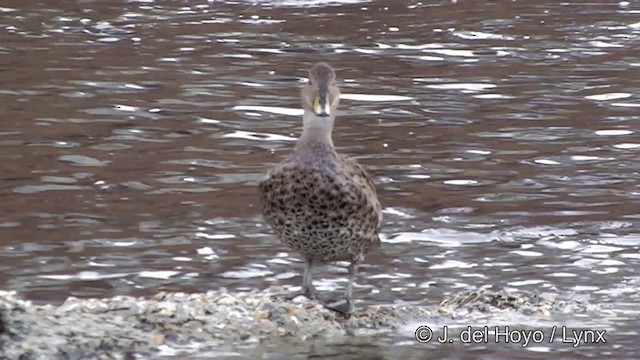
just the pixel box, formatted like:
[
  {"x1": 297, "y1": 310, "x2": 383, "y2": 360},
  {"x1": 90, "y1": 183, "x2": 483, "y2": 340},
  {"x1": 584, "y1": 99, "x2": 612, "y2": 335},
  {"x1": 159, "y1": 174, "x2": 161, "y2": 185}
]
[{"x1": 260, "y1": 62, "x2": 382, "y2": 317}]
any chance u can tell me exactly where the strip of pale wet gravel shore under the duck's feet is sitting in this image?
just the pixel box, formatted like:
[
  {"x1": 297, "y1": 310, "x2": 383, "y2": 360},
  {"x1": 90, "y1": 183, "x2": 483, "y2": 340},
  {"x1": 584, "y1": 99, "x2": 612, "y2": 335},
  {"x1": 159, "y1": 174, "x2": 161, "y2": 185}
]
[{"x1": 0, "y1": 287, "x2": 590, "y2": 360}]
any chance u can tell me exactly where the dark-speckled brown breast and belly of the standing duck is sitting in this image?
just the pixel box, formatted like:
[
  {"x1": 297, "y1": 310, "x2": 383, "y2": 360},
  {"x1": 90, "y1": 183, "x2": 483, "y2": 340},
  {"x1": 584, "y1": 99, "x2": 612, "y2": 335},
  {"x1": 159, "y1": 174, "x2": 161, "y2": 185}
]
[{"x1": 260, "y1": 148, "x2": 381, "y2": 261}]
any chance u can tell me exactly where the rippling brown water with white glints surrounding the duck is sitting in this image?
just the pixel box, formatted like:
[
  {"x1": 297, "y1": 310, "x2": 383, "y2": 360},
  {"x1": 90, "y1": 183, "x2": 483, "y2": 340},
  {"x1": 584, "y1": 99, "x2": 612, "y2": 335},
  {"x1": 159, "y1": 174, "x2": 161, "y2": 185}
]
[{"x1": 0, "y1": 0, "x2": 640, "y2": 359}]
